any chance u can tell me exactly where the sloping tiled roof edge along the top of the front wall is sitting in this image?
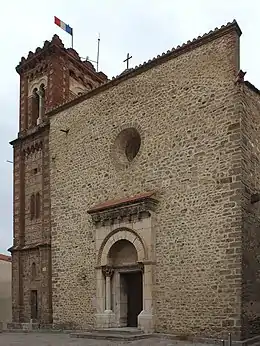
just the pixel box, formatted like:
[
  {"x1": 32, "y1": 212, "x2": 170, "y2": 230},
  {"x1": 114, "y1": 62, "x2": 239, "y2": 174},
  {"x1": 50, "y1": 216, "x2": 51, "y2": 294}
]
[{"x1": 47, "y1": 20, "x2": 242, "y2": 116}]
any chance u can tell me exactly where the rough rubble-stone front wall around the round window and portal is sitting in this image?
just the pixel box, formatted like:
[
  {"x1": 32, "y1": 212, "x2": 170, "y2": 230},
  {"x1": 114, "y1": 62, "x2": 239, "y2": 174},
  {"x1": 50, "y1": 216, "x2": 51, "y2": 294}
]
[{"x1": 50, "y1": 26, "x2": 245, "y2": 338}]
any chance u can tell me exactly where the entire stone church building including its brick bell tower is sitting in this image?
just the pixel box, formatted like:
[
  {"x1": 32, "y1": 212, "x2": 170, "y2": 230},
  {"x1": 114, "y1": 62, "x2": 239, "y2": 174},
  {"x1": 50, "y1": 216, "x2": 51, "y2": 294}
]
[{"x1": 11, "y1": 22, "x2": 260, "y2": 340}]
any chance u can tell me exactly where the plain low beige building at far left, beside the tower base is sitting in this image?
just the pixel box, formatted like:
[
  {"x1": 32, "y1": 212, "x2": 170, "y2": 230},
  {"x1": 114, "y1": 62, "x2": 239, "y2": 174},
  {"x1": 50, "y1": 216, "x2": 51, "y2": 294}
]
[{"x1": 0, "y1": 254, "x2": 12, "y2": 322}]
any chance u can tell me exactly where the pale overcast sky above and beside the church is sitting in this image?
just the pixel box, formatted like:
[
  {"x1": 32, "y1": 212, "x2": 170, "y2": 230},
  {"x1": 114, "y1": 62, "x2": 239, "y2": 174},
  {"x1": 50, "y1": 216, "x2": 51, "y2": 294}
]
[{"x1": 0, "y1": 0, "x2": 260, "y2": 253}]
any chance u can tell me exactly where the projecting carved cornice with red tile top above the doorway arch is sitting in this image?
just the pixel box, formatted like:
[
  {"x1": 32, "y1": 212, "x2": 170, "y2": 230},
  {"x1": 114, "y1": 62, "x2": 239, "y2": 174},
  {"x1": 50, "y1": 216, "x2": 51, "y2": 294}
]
[{"x1": 88, "y1": 193, "x2": 158, "y2": 225}]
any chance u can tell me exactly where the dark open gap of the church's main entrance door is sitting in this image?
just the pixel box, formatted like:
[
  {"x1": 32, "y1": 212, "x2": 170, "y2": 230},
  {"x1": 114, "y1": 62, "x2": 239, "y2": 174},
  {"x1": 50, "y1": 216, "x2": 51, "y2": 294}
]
[{"x1": 123, "y1": 271, "x2": 143, "y2": 327}]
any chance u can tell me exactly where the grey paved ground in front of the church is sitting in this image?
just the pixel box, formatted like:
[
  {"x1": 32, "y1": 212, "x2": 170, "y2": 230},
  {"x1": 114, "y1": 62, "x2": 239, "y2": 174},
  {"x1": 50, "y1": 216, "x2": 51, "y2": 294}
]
[{"x1": 0, "y1": 333, "x2": 210, "y2": 346}]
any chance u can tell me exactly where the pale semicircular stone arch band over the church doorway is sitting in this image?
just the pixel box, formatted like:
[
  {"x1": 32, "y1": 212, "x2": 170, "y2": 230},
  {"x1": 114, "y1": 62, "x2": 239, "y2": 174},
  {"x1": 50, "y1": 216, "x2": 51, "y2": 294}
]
[{"x1": 98, "y1": 228, "x2": 147, "y2": 266}]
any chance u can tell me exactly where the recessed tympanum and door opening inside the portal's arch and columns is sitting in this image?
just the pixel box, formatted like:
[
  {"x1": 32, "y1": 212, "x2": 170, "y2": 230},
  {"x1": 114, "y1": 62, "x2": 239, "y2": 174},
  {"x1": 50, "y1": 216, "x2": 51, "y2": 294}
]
[{"x1": 108, "y1": 239, "x2": 143, "y2": 327}]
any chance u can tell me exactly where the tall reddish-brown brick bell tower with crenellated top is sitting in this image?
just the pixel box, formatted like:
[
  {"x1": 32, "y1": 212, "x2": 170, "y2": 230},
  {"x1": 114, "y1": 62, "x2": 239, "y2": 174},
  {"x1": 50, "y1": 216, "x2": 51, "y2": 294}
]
[{"x1": 10, "y1": 35, "x2": 107, "y2": 325}]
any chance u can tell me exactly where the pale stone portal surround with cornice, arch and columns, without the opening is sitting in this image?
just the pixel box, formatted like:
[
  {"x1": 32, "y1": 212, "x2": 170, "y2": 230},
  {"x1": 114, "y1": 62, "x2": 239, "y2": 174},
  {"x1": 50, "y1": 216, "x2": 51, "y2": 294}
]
[{"x1": 88, "y1": 193, "x2": 157, "y2": 333}]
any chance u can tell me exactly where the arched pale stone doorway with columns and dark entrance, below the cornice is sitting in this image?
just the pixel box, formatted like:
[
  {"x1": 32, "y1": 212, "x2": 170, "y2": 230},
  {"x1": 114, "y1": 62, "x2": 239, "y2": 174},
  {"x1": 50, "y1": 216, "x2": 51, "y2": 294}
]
[{"x1": 95, "y1": 228, "x2": 154, "y2": 332}]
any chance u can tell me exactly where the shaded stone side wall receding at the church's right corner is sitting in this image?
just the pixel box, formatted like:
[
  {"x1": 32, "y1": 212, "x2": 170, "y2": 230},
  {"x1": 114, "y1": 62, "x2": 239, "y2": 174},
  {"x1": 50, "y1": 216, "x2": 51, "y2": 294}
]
[{"x1": 241, "y1": 86, "x2": 260, "y2": 337}]
